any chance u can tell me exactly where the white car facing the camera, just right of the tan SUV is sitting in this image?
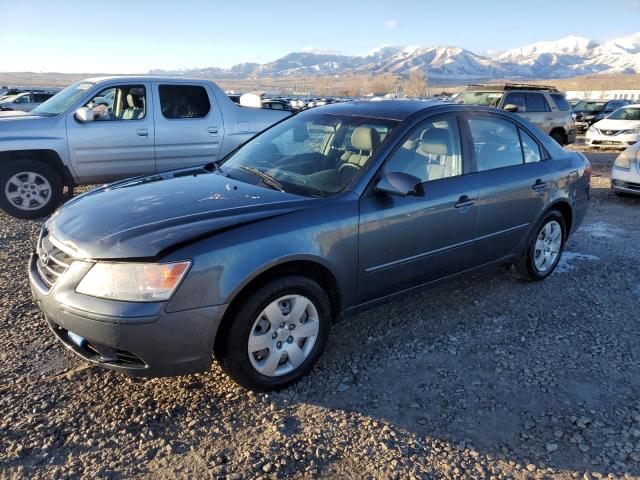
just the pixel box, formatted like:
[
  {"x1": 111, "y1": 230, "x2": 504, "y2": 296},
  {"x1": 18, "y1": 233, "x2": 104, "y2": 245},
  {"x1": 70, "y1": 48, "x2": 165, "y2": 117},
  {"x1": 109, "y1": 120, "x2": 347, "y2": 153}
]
[{"x1": 586, "y1": 105, "x2": 640, "y2": 148}]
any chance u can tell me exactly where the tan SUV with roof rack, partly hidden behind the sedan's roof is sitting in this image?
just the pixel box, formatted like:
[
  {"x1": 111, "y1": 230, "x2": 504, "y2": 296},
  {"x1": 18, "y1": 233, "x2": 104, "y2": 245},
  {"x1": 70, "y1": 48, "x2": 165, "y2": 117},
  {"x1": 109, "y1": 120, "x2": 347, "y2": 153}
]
[{"x1": 455, "y1": 83, "x2": 576, "y2": 145}]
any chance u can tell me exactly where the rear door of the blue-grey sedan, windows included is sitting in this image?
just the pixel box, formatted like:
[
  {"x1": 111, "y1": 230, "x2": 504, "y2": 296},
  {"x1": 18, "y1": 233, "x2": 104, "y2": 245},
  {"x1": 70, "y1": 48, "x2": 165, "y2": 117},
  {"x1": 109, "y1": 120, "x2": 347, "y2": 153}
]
[{"x1": 466, "y1": 114, "x2": 553, "y2": 263}]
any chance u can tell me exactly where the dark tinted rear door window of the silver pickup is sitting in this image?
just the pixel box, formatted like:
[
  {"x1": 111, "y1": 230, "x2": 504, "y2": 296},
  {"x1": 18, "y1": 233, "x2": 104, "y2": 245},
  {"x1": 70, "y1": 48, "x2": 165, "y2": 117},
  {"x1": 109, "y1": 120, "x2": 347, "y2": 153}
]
[{"x1": 158, "y1": 85, "x2": 211, "y2": 118}]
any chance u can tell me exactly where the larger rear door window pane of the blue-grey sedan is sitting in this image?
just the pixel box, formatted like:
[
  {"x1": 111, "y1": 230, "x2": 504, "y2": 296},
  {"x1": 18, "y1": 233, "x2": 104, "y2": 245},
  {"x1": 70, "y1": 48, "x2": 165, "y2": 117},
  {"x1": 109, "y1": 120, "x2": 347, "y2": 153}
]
[{"x1": 468, "y1": 116, "x2": 522, "y2": 172}]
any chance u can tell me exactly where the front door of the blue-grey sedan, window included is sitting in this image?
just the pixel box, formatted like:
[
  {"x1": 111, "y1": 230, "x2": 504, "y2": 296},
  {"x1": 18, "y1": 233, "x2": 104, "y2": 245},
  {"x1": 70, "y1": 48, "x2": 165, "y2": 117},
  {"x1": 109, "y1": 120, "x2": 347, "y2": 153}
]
[{"x1": 359, "y1": 115, "x2": 478, "y2": 303}]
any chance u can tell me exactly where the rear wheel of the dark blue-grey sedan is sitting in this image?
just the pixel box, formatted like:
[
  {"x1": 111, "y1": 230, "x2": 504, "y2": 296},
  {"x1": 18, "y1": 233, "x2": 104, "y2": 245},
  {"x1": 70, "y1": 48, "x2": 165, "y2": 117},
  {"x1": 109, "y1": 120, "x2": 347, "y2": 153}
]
[{"x1": 514, "y1": 210, "x2": 567, "y2": 282}]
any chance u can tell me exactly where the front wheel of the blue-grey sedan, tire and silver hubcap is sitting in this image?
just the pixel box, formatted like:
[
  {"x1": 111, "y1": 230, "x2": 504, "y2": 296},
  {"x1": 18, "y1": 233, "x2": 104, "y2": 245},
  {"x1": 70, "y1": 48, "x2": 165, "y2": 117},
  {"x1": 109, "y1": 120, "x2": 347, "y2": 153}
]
[{"x1": 214, "y1": 276, "x2": 331, "y2": 392}]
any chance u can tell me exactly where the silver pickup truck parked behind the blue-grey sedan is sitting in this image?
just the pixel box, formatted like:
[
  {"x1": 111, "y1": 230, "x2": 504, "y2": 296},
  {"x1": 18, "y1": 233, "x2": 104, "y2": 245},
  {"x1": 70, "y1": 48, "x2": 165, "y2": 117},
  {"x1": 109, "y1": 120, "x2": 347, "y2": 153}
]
[{"x1": 0, "y1": 76, "x2": 290, "y2": 218}]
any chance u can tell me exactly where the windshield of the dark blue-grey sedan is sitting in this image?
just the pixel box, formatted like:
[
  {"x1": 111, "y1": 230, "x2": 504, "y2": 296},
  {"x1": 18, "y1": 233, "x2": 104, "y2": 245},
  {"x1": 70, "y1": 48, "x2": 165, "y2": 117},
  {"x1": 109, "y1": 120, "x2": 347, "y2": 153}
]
[{"x1": 218, "y1": 113, "x2": 397, "y2": 197}]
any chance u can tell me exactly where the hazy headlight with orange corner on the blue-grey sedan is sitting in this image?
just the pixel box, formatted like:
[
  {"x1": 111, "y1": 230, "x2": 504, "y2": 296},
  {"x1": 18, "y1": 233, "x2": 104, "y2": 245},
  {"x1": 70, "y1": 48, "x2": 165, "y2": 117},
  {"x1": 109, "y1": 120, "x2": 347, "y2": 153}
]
[{"x1": 76, "y1": 261, "x2": 191, "y2": 302}]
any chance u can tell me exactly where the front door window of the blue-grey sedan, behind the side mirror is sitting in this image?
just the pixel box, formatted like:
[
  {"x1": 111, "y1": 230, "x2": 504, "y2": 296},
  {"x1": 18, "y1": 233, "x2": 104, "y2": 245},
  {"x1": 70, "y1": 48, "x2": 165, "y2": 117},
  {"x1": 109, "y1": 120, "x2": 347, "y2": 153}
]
[{"x1": 383, "y1": 117, "x2": 462, "y2": 182}]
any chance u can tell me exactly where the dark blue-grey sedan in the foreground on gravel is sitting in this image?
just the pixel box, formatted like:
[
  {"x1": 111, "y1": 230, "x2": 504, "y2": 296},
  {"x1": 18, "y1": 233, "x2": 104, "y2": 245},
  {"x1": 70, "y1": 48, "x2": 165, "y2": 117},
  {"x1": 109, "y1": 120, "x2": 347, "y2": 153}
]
[{"x1": 29, "y1": 101, "x2": 591, "y2": 390}]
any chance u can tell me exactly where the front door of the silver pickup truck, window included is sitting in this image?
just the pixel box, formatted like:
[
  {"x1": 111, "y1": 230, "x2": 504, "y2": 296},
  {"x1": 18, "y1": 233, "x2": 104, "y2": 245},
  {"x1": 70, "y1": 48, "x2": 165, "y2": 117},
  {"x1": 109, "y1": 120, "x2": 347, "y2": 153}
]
[{"x1": 66, "y1": 82, "x2": 155, "y2": 183}]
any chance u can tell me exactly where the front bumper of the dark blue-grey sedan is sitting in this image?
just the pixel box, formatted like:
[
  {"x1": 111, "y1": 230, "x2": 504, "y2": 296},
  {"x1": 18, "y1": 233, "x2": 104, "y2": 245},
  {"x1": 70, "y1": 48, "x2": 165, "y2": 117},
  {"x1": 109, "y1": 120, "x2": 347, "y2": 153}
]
[{"x1": 29, "y1": 253, "x2": 226, "y2": 377}]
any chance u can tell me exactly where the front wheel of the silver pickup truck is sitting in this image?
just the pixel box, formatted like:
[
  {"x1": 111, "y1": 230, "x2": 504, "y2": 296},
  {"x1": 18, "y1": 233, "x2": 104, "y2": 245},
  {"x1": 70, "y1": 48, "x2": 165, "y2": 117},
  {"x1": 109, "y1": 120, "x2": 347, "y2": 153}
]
[{"x1": 0, "y1": 159, "x2": 64, "y2": 219}]
